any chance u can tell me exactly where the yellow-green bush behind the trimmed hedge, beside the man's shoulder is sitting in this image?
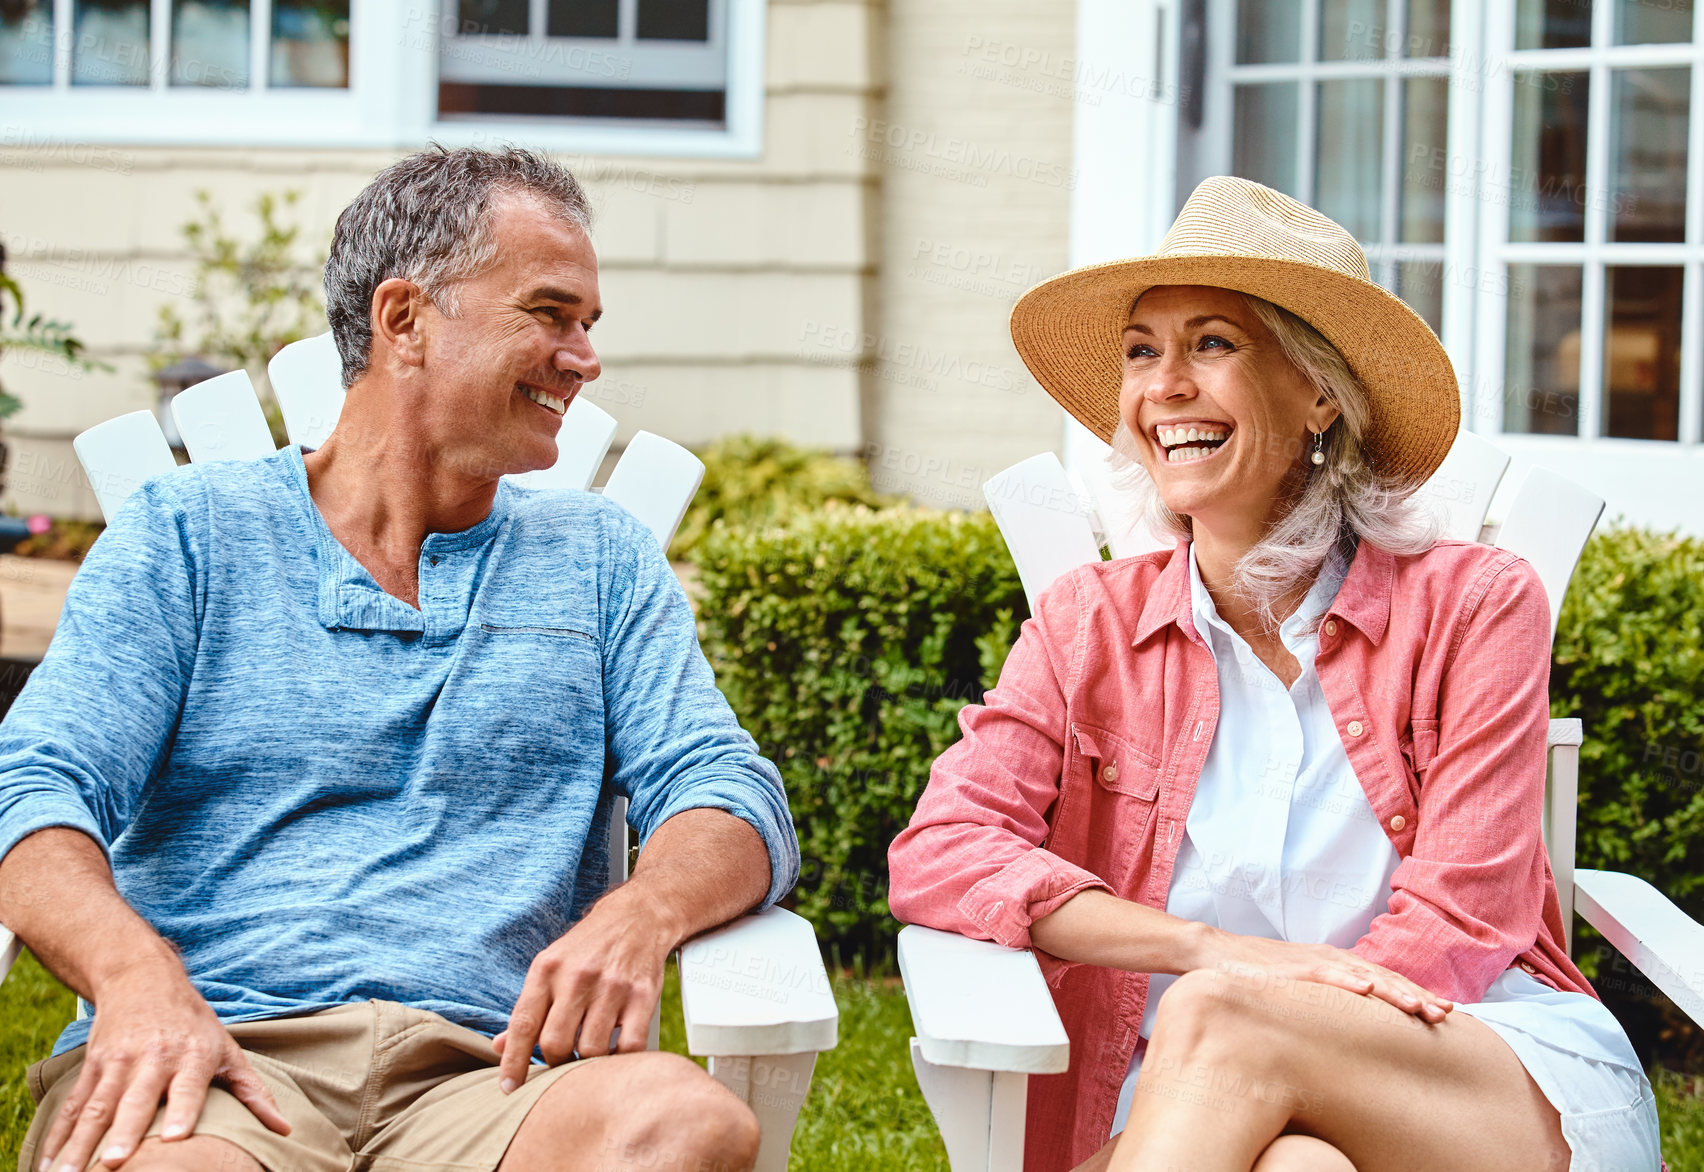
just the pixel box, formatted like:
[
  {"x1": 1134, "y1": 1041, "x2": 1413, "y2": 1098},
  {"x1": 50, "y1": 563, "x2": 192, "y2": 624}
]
[{"x1": 668, "y1": 436, "x2": 888, "y2": 560}]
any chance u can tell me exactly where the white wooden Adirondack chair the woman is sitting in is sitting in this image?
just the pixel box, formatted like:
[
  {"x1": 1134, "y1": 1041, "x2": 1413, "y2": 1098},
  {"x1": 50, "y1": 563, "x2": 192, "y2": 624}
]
[{"x1": 900, "y1": 434, "x2": 1704, "y2": 1172}]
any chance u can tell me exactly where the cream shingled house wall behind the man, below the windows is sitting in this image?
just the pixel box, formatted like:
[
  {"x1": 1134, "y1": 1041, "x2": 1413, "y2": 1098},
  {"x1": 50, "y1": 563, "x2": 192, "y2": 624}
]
[{"x1": 0, "y1": 0, "x2": 886, "y2": 518}]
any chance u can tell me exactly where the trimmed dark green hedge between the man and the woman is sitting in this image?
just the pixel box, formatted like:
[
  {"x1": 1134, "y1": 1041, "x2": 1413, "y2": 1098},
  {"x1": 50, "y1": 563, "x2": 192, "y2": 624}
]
[{"x1": 695, "y1": 506, "x2": 1028, "y2": 956}]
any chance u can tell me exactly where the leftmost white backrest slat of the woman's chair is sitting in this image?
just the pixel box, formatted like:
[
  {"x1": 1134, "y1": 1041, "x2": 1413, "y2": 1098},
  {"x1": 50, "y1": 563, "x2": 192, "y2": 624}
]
[{"x1": 982, "y1": 451, "x2": 1101, "y2": 612}]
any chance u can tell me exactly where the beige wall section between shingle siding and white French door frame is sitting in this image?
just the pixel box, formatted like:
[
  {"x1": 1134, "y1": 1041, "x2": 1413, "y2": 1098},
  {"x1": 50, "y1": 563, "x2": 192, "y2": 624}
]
[{"x1": 865, "y1": 0, "x2": 1077, "y2": 508}]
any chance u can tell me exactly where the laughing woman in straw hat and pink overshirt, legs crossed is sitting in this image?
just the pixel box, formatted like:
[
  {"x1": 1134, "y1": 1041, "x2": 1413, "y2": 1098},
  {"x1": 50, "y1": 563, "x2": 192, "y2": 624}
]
[{"x1": 889, "y1": 177, "x2": 1660, "y2": 1172}]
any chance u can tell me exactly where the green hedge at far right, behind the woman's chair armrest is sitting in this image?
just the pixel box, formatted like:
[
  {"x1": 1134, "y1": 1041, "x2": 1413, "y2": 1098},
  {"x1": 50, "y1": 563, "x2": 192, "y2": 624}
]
[{"x1": 1551, "y1": 528, "x2": 1704, "y2": 918}]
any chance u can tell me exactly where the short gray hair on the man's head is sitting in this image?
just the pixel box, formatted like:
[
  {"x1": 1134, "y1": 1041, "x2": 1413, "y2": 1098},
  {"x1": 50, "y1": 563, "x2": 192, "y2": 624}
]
[{"x1": 325, "y1": 143, "x2": 591, "y2": 387}]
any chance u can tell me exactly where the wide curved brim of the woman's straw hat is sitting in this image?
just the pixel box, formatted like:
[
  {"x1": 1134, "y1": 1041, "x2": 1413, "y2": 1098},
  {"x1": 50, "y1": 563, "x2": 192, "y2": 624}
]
[{"x1": 1012, "y1": 254, "x2": 1462, "y2": 489}]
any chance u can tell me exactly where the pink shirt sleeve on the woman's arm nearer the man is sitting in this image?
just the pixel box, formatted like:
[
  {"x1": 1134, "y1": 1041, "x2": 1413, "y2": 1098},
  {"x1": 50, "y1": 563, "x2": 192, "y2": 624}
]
[{"x1": 888, "y1": 574, "x2": 1111, "y2": 949}]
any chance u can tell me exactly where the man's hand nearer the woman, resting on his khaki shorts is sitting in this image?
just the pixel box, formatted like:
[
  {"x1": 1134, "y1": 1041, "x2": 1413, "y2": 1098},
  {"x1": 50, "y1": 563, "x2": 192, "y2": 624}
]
[{"x1": 492, "y1": 888, "x2": 678, "y2": 1092}]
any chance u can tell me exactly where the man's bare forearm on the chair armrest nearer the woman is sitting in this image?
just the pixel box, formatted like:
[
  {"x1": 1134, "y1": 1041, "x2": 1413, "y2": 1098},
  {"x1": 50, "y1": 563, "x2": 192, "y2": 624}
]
[{"x1": 600, "y1": 809, "x2": 770, "y2": 947}]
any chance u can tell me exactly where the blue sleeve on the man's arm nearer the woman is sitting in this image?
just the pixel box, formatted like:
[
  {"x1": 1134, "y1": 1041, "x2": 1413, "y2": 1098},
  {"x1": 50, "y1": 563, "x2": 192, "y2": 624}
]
[{"x1": 603, "y1": 513, "x2": 799, "y2": 908}]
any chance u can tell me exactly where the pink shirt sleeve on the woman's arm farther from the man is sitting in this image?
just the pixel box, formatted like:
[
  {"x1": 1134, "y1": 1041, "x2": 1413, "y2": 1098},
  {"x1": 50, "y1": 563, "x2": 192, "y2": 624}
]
[{"x1": 1355, "y1": 559, "x2": 1551, "y2": 1002}]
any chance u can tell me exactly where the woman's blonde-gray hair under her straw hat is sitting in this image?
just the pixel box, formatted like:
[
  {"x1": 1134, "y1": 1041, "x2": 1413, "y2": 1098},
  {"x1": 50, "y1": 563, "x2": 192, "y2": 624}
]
[{"x1": 1108, "y1": 293, "x2": 1438, "y2": 630}]
